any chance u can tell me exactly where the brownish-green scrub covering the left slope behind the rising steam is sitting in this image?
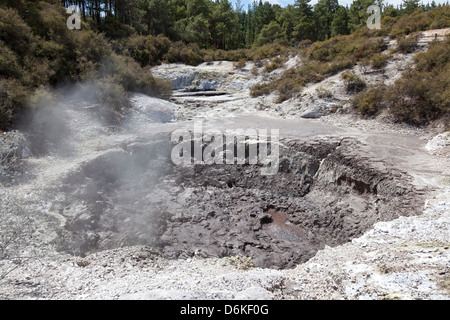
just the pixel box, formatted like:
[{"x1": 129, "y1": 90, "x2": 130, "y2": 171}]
[{"x1": 0, "y1": 1, "x2": 175, "y2": 129}]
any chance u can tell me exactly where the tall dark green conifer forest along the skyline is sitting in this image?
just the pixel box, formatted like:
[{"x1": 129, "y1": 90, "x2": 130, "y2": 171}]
[{"x1": 56, "y1": 0, "x2": 450, "y2": 50}]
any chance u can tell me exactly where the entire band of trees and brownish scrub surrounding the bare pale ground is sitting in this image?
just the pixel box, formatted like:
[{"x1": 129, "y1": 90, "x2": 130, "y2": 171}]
[{"x1": 0, "y1": 0, "x2": 450, "y2": 130}]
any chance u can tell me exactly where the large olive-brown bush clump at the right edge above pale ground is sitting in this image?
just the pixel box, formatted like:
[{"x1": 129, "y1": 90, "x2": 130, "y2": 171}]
[{"x1": 352, "y1": 39, "x2": 450, "y2": 126}]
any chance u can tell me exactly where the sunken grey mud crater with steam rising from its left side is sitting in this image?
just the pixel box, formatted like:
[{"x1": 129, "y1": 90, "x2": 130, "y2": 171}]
[{"x1": 48, "y1": 134, "x2": 423, "y2": 268}]
